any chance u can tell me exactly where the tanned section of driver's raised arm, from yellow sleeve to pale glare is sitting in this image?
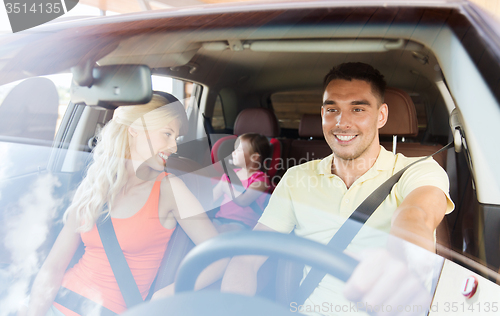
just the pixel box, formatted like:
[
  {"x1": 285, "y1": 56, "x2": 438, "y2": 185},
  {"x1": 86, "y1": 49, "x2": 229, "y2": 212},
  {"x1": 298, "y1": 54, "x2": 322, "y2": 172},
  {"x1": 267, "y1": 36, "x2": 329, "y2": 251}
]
[{"x1": 390, "y1": 186, "x2": 447, "y2": 252}]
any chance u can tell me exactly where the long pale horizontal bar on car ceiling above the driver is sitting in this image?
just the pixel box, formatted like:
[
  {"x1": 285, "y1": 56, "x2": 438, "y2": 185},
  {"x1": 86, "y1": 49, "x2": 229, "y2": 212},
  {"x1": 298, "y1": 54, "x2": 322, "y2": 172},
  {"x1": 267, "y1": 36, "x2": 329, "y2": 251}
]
[{"x1": 250, "y1": 39, "x2": 405, "y2": 53}]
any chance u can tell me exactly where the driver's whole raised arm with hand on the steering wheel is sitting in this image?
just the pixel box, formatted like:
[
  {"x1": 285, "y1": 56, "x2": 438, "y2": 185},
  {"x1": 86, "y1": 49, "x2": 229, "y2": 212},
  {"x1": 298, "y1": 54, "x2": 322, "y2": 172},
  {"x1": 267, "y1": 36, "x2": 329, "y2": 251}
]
[{"x1": 344, "y1": 186, "x2": 448, "y2": 310}]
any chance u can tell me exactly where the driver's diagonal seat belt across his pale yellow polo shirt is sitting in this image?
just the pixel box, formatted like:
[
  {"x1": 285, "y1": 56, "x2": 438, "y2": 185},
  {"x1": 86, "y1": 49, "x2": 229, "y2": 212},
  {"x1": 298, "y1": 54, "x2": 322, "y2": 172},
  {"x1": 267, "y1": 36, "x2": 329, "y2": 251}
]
[{"x1": 294, "y1": 142, "x2": 453, "y2": 304}]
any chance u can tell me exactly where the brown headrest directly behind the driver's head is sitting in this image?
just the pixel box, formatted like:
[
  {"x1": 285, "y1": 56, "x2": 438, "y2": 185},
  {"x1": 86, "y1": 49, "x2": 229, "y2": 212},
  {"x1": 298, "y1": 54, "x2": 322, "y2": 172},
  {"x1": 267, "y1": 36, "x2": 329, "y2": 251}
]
[{"x1": 379, "y1": 88, "x2": 418, "y2": 137}]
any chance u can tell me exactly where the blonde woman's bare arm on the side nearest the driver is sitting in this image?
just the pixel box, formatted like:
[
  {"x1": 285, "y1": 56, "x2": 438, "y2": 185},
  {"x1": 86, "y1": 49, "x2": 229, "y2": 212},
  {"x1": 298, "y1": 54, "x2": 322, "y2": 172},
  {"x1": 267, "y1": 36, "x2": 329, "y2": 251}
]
[{"x1": 153, "y1": 177, "x2": 229, "y2": 299}]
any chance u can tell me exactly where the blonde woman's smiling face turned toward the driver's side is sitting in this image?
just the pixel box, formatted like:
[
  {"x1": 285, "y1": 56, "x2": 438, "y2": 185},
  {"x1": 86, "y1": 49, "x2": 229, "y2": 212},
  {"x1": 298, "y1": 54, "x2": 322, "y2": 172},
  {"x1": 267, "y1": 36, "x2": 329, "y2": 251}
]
[{"x1": 129, "y1": 120, "x2": 180, "y2": 171}]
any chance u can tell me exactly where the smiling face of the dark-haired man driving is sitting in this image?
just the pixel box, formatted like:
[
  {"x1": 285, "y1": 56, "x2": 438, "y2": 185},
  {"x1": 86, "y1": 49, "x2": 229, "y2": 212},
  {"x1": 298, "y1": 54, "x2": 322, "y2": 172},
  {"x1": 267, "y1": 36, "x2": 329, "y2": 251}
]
[{"x1": 321, "y1": 79, "x2": 388, "y2": 160}]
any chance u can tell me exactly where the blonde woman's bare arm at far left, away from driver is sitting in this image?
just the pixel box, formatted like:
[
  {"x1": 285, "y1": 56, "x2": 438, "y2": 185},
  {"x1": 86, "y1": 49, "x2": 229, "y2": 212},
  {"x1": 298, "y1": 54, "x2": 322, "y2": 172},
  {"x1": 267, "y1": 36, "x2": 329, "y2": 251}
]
[{"x1": 27, "y1": 212, "x2": 81, "y2": 316}]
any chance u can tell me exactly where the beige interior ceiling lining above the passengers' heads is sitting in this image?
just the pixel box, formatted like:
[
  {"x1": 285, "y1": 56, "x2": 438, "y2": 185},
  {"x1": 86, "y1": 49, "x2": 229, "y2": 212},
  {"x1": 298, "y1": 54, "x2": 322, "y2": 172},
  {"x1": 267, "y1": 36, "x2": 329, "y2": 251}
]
[{"x1": 99, "y1": 26, "x2": 442, "y2": 90}]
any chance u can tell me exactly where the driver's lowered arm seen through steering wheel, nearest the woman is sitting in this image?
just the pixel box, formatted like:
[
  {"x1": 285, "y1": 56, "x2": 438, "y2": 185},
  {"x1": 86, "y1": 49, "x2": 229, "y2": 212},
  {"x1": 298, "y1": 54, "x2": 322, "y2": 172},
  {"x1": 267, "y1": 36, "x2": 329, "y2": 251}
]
[{"x1": 221, "y1": 223, "x2": 275, "y2": 296}]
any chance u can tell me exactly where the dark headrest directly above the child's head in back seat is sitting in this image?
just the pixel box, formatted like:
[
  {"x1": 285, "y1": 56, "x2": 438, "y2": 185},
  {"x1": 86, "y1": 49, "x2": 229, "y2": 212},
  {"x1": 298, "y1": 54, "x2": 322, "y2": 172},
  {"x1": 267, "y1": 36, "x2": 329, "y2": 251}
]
[{"x1": 234, "y1": 108, "x2": 280, "y2": 137}]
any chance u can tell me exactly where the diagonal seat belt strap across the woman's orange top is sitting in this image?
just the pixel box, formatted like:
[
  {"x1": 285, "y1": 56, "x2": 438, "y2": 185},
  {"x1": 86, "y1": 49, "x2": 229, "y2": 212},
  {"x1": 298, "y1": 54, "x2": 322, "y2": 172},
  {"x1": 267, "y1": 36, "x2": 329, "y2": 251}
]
[{"x1": 97, "y1": 210, "x2": 144, "y2": 308}]
